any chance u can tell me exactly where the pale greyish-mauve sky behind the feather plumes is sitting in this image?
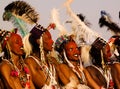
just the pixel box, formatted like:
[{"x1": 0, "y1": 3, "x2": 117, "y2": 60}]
[{"x1": 0, "y1": 0, "x2": 120, "y2": 39}]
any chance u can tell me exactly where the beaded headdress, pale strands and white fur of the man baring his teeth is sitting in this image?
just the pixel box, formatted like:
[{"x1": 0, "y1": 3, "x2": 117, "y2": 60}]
[{"x1": 55, "y1": 35, "x2": 90, "y2": 89}]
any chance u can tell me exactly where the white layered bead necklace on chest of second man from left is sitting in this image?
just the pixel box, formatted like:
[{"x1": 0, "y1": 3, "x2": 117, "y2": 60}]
[{"x1": 29, "y1": 56, "x2": 60, "y2": 89}]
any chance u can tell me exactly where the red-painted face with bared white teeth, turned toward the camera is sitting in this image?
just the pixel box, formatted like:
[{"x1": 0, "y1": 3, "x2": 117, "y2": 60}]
[{"x1": 65, "y1": 41, "x2": 80, "y2": 60}]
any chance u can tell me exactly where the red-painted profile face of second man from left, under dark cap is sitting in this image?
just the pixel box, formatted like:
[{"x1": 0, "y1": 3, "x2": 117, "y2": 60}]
[{"x1": 43, "y1": 31, "x2": 53, "y2": 51}]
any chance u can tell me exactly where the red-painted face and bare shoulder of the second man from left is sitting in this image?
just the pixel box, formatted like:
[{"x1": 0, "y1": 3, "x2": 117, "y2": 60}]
[{"x1": 25, "y1": 31, "x2": 58, "y2": 89}]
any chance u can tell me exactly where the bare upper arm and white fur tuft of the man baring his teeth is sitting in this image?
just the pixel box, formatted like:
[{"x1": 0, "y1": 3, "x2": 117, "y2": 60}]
[{"x1": 57, "y1": 64, "x2": 79, "y2": 87}]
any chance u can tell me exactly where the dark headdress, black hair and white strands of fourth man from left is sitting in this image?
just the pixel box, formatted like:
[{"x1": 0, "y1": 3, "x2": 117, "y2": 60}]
[{"x1": 90, "y1": 37, "x2": 114, "y2": 89}]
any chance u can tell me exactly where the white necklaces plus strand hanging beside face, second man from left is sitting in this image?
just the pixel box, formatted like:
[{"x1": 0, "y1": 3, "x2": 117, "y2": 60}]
[{"x1": 29, "y1": 36, "x2": 59, "y2": 89}]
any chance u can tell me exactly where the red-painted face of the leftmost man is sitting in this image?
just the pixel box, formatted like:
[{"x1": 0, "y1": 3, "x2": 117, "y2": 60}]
[{"x1": 8, "y1": 33, "x2": 24, "y2": 55}]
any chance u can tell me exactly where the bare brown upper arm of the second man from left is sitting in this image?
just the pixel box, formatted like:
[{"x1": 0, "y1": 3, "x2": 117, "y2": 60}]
[{"x1": 25, "y1": 57, "x2": 48, "y2": 88}]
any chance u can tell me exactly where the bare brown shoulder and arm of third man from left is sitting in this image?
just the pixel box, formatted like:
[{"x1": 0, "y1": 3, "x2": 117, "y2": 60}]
[{"x1": 50, "y1": 57, "x2": 78, "y2": 85}]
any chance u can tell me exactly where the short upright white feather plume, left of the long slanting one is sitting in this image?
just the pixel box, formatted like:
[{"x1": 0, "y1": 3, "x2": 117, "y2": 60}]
[{"x1": 51, "y1": 8, "x2": 67, "y2": 35}]
